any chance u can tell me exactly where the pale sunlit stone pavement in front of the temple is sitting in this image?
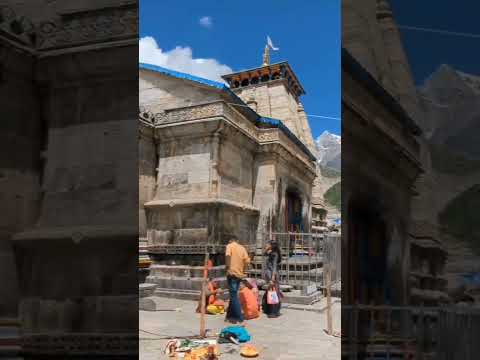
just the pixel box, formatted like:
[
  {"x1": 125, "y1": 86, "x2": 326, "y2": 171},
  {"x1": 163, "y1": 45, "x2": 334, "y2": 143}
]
[{"x1": 139, "y1": 298, "x2": 341, "y2": 360}]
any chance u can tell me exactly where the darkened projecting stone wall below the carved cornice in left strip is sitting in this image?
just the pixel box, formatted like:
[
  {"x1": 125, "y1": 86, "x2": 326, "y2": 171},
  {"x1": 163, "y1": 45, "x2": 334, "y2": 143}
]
[{"x1": 13, "y1": 46, "x2": 138, "y2": 354}]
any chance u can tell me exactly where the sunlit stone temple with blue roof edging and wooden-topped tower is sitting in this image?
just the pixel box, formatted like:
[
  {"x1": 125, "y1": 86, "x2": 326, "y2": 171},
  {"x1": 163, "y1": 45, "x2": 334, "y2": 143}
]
[{"x1": 139, "y1": 50, "x2": 326, "y2": 295}]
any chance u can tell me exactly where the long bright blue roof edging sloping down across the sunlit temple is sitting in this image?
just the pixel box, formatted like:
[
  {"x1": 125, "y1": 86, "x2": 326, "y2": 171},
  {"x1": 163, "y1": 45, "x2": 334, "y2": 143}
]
[{"x1": 139, "y1": 63, "x2": 316, "y2": 161}]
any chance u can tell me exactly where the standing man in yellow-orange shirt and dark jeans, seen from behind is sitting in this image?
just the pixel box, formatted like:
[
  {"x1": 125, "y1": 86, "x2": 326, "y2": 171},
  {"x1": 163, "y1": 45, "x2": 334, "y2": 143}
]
[{"x1": 225, "y1": 236, "x2": 250, "y2": 326}]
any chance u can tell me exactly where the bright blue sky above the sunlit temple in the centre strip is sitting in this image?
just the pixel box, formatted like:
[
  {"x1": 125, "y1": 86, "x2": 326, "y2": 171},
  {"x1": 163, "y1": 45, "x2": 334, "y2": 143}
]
[{"x1": 140, "y1": 0, "x2": 341, "y2": 138}]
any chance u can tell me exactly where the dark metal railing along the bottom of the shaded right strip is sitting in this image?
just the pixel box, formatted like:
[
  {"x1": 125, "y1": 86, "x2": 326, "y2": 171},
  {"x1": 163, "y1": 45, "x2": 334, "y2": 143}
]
[{"x1": 342, "y1": 305, "x2": 480, "y2": 360}]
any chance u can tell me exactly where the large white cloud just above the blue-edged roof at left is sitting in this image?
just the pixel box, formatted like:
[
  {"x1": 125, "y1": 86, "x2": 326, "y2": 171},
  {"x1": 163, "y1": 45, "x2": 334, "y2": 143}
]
[{"x1": 139, "y1": 36, "x2": 233, "y2": 82}]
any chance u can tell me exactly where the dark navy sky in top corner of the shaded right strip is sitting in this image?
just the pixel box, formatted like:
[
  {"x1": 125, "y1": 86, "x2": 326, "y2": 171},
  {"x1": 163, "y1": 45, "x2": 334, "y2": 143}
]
[{"x1": 391, "y1": 0, "x2": 480, "y2": 84}]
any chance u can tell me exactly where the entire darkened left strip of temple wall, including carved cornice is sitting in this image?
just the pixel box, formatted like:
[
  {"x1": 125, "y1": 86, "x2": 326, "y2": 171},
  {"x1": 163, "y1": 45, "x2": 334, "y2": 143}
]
[{"x1": 0, "y1": 0, "x2": 138, "y2": 358}]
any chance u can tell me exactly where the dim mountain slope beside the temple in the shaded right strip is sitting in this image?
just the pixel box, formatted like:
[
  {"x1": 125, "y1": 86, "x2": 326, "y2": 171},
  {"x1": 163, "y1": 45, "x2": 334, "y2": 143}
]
[{"x1": 418, "y1": 65, "x2": 480, "y2": 282}]
